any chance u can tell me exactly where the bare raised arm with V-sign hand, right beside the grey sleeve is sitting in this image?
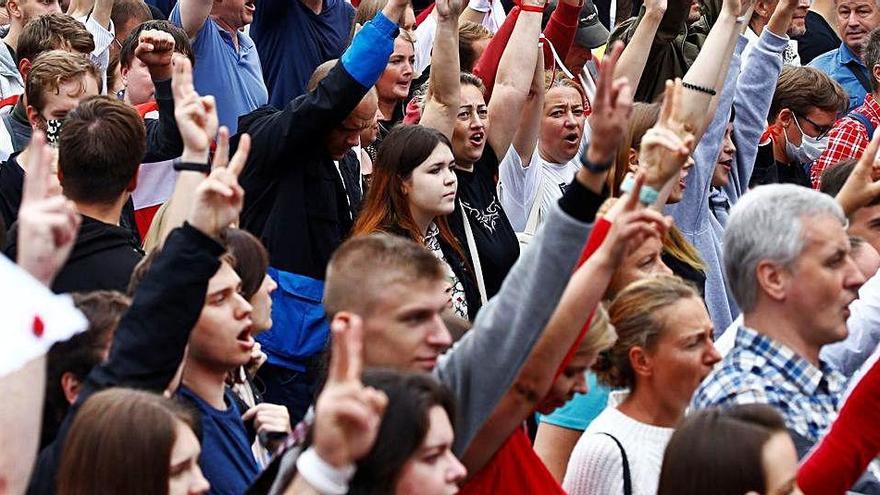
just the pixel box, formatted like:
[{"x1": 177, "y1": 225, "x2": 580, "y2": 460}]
[{"x1": 462, "y1": 180, "x2": 666, "y2": 474}]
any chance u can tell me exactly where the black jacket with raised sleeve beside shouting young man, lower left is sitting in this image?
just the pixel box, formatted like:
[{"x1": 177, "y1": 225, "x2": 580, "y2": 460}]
[{"x1": 27, "y1": 225, "x2": 224, "y2": 495}]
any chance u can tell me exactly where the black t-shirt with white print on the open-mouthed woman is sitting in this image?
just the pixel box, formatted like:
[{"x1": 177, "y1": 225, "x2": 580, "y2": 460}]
[{"x1": 448, "y1": 146, "x2": 519, "y2": 297}]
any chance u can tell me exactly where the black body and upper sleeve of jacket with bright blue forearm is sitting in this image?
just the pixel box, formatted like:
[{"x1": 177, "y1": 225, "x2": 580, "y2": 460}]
[{"x1": 233, "y1": 64, "x2": 370, "y2": 280}]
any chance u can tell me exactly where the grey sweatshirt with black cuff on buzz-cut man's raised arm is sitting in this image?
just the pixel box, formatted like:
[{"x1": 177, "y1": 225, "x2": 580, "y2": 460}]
[{"x1": 269, "y1": 183, "x2": 603, "y2": 495}]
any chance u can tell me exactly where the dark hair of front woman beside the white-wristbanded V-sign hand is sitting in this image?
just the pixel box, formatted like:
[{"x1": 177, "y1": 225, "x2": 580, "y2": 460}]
[{"x1": 348, "y1": 370, "x2": 455, "y2": 495}]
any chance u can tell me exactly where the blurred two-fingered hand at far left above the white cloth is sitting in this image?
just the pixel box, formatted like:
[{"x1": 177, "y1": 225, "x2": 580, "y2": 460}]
[{"x1": 17, "y1": 131, "x2": 81, "y2": 286}]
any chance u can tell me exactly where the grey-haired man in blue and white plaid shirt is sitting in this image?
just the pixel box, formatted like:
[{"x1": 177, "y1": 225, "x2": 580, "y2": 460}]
[{"x1": 693, "y1": 184, "x2": 864, "y2": 455}]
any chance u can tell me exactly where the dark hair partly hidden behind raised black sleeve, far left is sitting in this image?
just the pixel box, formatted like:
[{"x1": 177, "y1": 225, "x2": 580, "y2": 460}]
[{"x1": 40, "y1": 291, "x2": 131, "y2": 446}]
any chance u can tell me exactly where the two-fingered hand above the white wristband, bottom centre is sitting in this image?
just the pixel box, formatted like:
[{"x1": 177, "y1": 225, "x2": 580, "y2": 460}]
[{"x1": 314, "y1": 316, "x2": 388, "y2": 467}]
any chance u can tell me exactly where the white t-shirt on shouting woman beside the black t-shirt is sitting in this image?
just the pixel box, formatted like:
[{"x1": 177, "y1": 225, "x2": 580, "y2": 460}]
[{"x1": 498, "y1": 146, "x2": 581, "y2": 232}]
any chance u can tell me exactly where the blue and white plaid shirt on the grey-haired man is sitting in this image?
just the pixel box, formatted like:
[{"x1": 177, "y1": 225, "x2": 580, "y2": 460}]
[{"x1": 692, "y1": 327, "x2": 846, "y2": 443}]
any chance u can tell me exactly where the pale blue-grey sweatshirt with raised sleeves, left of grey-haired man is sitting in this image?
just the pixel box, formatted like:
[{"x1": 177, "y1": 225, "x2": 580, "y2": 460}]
[{"x1": 666, "y1": 29, "x2": 787, "y2": 337}]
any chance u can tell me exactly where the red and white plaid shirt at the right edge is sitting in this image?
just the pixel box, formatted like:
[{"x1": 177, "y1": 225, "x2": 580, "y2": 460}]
[{"x1": 810, "y1": 93, "x2": 880, "y2": 189}]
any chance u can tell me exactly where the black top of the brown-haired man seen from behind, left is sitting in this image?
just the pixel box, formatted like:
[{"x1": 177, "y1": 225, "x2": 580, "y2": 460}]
[{"x1": 6, "y1": 215, "x2": 144, "y2": 294}]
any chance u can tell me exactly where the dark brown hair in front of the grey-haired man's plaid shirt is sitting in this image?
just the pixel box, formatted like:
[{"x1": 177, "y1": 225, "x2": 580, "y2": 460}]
[{"x1": 657, "y1": 404, "x2": 787, "y2": 495}]
